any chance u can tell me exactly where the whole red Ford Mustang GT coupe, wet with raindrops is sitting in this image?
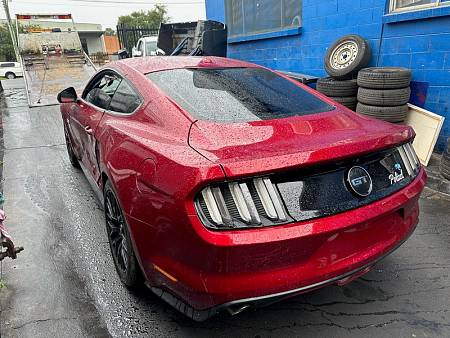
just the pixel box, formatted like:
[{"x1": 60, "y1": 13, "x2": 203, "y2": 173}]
[{"x1": 58, "y1": 57, "x2": 426, "y2": 320}]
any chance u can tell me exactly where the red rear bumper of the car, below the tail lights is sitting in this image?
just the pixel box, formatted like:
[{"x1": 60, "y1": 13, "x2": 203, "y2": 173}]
[{"x1": 145, "y1": 169, "x2": 426, "y2": 320}]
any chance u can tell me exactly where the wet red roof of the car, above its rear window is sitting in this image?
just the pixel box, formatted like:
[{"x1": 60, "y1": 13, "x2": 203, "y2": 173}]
[{"x1": 116, "y1": 56, "x2": 259, "y2": 74}]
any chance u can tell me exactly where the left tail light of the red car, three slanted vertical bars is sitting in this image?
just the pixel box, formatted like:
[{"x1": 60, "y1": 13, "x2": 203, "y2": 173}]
[{"x1": 196, "y1": 177, "x2": 289, "y2": 229}]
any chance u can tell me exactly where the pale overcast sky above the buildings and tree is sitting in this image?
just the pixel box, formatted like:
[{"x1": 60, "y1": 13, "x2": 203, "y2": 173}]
[{"x1": 0, "y1": 0, "x2": 205, "y2": 29}]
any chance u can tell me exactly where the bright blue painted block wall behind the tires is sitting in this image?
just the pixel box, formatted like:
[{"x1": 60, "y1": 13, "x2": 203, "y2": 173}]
[{"x1": 206, "y1": 0, "x2": 450, "y2": 151}]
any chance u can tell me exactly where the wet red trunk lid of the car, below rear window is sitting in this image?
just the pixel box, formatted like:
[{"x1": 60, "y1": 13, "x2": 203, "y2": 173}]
[{"x1": 189, "y1": 109, "x2": 414, "y2": 178}]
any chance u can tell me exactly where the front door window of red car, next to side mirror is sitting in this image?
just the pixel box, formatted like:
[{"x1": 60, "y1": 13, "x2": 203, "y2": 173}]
[{"x1": 85, "y1": 73, "x2": 122, "y2": 109}]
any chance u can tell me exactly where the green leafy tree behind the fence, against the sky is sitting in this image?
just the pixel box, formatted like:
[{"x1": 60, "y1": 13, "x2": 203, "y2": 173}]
[{"x1": 118, "y1": 5, "x2": 169, "y2": 29}]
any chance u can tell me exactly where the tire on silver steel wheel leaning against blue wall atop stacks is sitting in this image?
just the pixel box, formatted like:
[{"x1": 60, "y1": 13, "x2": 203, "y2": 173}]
[{"x1": 325, "y1": 35, "x2": 371, "y2": 80}]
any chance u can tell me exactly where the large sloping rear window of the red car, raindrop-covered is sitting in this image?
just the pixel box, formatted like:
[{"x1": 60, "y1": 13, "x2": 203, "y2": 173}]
[{"x1": 147, "y1": 68, "x2": 334, "y2": 122}]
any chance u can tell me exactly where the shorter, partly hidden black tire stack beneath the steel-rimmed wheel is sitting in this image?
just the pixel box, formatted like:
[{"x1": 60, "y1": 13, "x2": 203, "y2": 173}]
[{"x1": 316, "y1": 77, "x2": 358, "y2": 110}]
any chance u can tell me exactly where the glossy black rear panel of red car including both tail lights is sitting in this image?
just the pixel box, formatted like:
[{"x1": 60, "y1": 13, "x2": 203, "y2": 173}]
[{"x1": 195, "y1": 143, "x2": 420, "y2": 230}]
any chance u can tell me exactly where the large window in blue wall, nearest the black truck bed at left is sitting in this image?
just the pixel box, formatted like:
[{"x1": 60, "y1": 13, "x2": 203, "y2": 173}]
[{"x1": 225, "y1": 0, "x2": 302, "y2": 38}]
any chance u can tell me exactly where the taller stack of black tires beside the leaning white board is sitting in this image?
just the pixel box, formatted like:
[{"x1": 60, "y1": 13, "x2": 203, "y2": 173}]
[{"x1": 356, "y1": 67, "x2": 411, "y2": 123}]
